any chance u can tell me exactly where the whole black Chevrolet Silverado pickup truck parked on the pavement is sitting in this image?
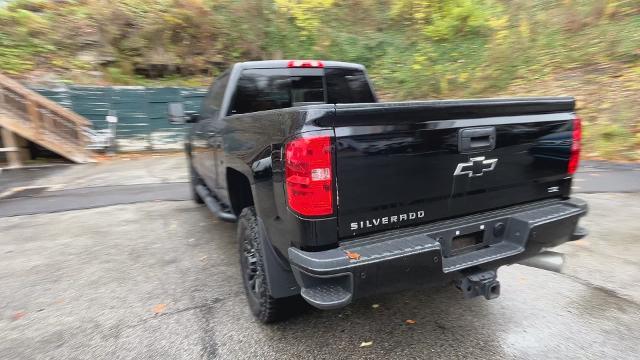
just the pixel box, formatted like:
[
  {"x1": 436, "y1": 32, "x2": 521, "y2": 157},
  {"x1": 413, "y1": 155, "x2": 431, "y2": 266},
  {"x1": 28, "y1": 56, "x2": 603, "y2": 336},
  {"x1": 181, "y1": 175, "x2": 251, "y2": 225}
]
[{"x1": 169, "y1": 60, "x2": 587, "y2": 322}]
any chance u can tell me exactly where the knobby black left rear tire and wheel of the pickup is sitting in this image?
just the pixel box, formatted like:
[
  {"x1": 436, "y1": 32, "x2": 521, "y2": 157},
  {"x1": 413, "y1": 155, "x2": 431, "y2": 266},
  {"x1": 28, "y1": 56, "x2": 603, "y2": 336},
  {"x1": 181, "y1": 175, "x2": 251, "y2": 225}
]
[{"x1": 238, "y1": 206, "x2": 286, "y2": 323}]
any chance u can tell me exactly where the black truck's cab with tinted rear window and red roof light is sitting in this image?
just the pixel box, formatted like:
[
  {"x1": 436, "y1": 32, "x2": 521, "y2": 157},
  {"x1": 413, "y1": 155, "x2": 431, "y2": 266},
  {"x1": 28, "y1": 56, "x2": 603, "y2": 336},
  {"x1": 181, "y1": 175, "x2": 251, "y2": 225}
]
[{"x1": 182, "y1": 61, "x2": 376, "y2": 211}]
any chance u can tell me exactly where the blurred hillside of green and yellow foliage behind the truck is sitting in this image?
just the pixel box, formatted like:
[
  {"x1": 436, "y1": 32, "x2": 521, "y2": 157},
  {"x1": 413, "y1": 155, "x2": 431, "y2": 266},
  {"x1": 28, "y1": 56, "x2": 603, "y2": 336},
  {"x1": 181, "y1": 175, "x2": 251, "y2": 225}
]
[{"x1": 0, "y1": 0, "x2": 640, "y2": 160}]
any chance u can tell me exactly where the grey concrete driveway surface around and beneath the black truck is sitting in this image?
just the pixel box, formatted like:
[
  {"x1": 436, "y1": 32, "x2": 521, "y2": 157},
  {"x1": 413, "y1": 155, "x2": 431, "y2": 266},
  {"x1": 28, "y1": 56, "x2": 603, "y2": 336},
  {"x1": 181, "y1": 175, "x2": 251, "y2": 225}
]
[{"x1": 0, "y1": 157, "x2": 640, "y2": 359}]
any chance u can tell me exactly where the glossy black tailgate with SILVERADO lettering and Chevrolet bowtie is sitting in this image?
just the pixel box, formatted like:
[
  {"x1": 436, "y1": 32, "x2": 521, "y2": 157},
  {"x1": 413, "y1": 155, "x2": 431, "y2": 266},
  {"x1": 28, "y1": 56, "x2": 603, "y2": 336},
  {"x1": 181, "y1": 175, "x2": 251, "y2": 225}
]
[{"x1": 334, "y1": 98, "x2": 575, "y2": 238}]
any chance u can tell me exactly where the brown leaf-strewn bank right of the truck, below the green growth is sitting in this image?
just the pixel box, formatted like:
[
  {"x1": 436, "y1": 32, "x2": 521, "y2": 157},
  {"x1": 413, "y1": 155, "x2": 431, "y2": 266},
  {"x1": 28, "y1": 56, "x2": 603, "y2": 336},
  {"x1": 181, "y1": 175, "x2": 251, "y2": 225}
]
[{"x1": 501, "y1": 64, "x2": 640, "y2": 161}]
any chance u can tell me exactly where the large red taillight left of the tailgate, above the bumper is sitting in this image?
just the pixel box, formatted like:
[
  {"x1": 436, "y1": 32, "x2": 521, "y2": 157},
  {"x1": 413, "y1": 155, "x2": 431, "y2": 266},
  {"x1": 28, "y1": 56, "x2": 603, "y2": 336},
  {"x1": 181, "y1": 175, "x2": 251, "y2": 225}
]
[{"x1": 285, "y1": 136, "x2": 333, "y2": 216}]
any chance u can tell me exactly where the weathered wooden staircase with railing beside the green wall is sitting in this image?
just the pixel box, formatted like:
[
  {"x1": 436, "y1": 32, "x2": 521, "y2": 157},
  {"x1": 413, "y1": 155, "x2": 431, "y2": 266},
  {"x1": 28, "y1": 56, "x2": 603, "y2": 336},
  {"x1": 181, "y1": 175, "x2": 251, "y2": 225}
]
[{"x1": 0, "y1": 74, "x2": 94, "y2": 166}]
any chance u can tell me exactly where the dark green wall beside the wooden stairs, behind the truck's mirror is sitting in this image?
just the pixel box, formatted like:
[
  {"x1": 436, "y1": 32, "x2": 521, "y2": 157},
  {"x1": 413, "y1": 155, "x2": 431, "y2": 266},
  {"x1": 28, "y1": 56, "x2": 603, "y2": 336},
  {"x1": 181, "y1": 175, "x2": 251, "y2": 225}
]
[{"x1": 34, "y1": 86, "x2": 207, "y2": 151}]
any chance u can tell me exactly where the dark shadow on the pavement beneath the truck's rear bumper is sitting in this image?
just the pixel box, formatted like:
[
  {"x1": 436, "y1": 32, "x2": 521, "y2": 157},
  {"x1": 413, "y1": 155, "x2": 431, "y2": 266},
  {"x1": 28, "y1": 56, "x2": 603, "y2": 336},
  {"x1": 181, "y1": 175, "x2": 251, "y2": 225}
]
[{"x1": 265, "y1": 287, "x2": 507, "y2": 357}]
